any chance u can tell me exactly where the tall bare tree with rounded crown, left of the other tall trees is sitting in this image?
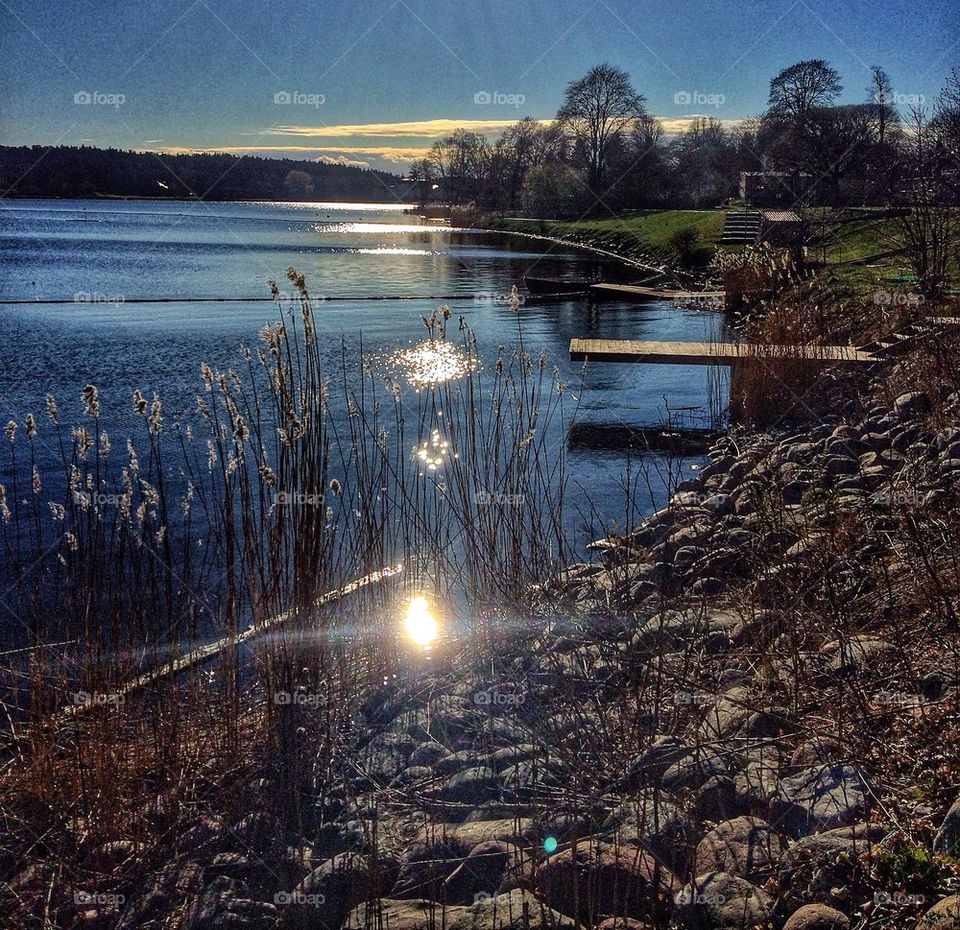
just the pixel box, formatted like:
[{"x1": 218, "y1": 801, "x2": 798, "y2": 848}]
[{"x1": 557, "y1": 64, "x2": 647, "y2": 192}]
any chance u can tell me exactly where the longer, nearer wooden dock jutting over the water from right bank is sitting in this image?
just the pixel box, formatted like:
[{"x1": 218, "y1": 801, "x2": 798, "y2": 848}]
[{"x1": 570, "y1": 339, "x2": 877, "y2": 365}]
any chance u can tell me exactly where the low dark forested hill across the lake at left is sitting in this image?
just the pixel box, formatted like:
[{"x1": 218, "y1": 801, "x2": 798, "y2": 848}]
[{"x1": 0, "y1": 145, "x2": 406, "y2": 201}]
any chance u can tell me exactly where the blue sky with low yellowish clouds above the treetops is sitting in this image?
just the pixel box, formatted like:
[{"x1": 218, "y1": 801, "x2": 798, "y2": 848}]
[{"x1": 0, "y1": 0, "x2": 960, "y2": 172}]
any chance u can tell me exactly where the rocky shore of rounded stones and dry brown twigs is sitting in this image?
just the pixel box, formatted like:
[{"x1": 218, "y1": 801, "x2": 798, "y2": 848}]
[{"x1": 50, "y1": 374, "x2": 960, "y2": 930}]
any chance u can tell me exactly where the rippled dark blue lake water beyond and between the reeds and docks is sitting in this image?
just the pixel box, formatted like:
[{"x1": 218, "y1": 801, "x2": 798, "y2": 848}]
[{"x1": 0, "y1": 201, "x2": 720, "y2": 542}]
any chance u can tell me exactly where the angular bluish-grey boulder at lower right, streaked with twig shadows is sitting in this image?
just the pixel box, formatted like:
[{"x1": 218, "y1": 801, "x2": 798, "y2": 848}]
[{"x1": 773, "y1": 763, "x2": 869, "y2": 836}]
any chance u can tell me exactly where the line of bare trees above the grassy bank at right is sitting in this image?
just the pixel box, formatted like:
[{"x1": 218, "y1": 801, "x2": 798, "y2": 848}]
[{"x1": 410, "y1": 59, "x2": 960, "y2": 217}]
